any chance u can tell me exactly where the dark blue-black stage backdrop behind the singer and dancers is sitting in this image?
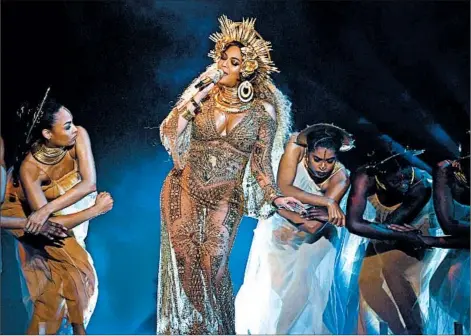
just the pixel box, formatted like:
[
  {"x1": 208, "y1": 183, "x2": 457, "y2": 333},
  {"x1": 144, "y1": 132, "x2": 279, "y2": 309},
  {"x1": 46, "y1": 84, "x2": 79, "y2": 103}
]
[{"x1": 0, "y1": 1, "x2": 470, "y2": 334}]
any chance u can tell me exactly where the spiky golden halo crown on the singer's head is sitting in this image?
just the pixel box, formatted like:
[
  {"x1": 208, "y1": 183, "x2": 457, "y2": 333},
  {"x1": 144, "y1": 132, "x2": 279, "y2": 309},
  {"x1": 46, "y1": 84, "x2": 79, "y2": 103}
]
[{"x1": 208, "y1": 15, "x2": 279, "y2": 84}]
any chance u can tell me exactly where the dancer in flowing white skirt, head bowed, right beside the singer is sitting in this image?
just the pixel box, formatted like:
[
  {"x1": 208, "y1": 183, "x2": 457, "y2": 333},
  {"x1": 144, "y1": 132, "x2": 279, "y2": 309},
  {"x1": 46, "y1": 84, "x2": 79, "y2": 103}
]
[{"x1": 235, "y1": 124, "x2": 374, "y2": 334}]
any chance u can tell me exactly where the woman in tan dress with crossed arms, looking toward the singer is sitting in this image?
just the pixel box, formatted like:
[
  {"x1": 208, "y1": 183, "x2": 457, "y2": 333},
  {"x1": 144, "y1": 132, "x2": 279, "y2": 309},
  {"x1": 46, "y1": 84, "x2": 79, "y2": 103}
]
[{"x1": 1, "y1": 95, "x2": 113, "y2": 334}]
